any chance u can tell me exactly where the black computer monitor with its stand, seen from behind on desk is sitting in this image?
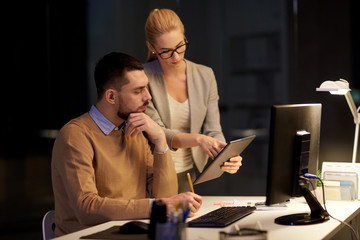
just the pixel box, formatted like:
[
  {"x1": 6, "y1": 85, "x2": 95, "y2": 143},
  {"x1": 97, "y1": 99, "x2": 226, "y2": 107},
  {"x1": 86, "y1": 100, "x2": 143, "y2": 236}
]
[{"x1": 266, "y1": 103, "x2": 329, "y2": 225}]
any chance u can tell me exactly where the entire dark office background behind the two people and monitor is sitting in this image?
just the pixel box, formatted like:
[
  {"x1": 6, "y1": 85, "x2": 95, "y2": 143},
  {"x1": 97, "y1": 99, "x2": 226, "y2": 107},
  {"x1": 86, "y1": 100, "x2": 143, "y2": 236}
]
[{"x1": 0, "y1": 0, "x2": 360, "y2": 239}]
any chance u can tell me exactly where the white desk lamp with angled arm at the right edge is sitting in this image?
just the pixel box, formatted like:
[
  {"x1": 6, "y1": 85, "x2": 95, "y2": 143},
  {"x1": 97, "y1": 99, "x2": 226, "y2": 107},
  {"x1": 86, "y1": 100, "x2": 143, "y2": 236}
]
[{"x1": 316, "y1": 78, "x2": 360, "y2": 163}]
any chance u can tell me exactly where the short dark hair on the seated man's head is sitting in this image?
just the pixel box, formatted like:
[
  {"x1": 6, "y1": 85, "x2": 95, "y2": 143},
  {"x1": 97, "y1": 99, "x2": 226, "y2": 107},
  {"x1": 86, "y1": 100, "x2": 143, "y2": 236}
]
[{"x1": 94, "y1": 52, "x2": 144, "y2": 100}]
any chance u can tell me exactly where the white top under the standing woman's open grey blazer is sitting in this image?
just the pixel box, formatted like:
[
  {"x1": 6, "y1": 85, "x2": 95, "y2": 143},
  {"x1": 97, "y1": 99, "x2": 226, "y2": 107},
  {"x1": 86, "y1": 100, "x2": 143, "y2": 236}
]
[{"x1": 167, "y1": 94, "x2": 193, "y2": 173}]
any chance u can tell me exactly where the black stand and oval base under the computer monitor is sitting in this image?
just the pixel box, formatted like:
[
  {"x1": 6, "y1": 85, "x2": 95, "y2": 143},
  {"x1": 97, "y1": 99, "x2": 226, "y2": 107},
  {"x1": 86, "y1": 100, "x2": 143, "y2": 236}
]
[{"x1": 275, "y1": 187, "x2": 329, "y2": 225}]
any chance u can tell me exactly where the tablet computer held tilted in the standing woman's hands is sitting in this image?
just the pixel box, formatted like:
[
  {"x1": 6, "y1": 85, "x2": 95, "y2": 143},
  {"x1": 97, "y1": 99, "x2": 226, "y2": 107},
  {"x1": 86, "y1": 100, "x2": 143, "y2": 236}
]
[{"x1": 194, "y1": 135, "x2": 256, "y2": 184}]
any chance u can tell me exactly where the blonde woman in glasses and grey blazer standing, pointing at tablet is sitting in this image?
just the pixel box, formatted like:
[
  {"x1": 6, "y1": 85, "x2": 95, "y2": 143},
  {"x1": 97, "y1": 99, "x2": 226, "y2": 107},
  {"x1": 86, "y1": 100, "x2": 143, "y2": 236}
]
[{"x1": 144, "y1": 9, "x2": 242, "y2": 193}]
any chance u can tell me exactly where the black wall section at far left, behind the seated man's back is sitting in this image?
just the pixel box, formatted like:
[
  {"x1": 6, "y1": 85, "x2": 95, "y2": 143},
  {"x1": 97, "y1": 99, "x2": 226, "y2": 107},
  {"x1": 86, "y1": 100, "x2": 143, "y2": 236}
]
[{"x1": 0, "y1": 1, "x2": 88, "y2": 239}]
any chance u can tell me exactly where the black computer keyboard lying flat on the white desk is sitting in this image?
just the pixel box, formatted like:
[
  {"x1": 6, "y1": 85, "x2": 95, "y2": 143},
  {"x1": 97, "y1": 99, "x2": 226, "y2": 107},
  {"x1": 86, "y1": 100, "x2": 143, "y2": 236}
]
[{"x1": 188, "y1": 206, "x2": 256, "y2": 227}]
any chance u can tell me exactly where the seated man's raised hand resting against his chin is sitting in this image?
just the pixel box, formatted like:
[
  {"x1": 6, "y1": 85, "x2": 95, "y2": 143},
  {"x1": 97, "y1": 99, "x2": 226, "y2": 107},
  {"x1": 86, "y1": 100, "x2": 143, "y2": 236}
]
[{"x1": 125, "y1": 113, "x2": 167, "y2": 152}]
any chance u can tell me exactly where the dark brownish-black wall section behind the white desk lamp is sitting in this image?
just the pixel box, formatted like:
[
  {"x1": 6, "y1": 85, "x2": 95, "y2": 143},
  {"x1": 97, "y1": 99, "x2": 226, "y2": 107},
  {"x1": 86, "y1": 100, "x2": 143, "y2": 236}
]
[{"x1": 291, "y1": 1, "x2": 359, "y2": 166}]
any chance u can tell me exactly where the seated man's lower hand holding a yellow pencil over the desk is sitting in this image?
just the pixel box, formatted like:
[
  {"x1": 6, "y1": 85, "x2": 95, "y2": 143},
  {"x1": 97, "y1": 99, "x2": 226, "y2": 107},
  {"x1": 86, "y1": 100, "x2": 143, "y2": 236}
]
[{"x1": 157, "y1": 192, "x2": 202, "y2": 217}]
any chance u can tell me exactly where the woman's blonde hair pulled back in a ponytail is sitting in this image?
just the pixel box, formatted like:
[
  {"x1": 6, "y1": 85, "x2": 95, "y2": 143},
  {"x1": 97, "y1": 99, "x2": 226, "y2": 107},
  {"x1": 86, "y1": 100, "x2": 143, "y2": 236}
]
[{"x1": 145, "y1": 9, "x2": 185, "y2": 62}]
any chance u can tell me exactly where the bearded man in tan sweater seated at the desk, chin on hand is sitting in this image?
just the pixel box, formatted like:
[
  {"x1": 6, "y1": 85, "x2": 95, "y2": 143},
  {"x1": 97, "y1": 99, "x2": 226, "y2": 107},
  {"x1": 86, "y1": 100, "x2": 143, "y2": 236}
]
[{"x1": 51, "y1": 53, "x2": 202, "y2": 236}]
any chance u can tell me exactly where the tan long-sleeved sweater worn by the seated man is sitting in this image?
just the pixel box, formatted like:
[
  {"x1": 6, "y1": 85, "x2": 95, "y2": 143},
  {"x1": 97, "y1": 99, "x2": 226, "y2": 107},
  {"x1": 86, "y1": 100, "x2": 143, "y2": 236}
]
[{"x1": 51, "y1": 113, "x2": 178, "y2": 236}]
